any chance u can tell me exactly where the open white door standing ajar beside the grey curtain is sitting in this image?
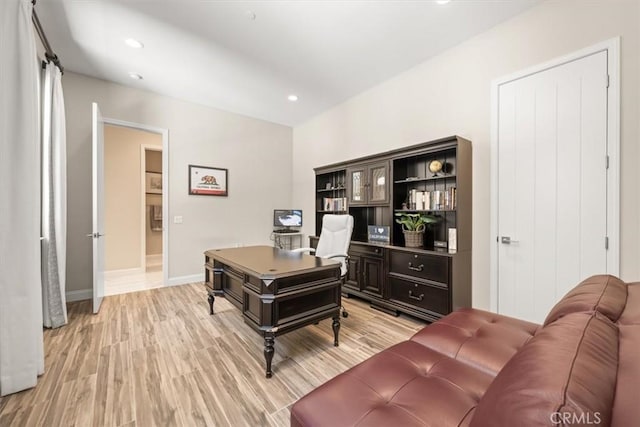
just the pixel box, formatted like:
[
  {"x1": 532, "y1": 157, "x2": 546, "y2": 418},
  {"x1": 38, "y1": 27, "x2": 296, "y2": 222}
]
[{"x1": 90, "y1": 102, "x2": 104, "y2": 313}]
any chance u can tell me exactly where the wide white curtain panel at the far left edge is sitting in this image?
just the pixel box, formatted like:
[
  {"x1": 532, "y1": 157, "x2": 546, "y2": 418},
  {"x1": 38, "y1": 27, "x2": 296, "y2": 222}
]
[{"x1": 0, "y1": 0, "x2": 44, "y2": 395}]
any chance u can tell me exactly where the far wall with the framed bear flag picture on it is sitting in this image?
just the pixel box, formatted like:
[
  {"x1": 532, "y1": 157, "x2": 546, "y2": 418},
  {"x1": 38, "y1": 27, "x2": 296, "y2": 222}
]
[{"x1": 63, "y1": 72, "x2": 292, "y2": 291}]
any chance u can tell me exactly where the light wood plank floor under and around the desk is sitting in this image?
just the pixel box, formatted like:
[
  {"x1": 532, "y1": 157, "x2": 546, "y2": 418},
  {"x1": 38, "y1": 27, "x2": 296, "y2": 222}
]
[{"x1": 0, "y1": 283, "x2": 425, "y2": 427}]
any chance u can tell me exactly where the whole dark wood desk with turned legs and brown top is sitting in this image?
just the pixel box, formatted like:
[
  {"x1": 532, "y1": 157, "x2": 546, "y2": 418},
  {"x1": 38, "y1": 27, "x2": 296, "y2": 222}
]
[{"x1": 204, "y1": 246, "x2": 341, "y2": 378}]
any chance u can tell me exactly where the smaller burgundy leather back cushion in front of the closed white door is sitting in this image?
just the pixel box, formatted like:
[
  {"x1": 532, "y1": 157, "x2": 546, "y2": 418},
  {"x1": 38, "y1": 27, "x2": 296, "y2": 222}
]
[{"x1": 544, "y1": 274, "x2": 627, "y2": 326}]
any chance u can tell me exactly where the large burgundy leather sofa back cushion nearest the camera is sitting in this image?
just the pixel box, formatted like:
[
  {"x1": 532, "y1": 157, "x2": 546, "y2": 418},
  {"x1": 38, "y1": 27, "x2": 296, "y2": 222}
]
[{"x1": 471, "y1": 312, "x2": 618, "y2": 427}]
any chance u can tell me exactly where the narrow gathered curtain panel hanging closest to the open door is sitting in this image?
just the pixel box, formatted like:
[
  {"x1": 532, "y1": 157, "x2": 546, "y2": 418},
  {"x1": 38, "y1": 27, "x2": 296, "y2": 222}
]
[{"x1": 42, "y1": 63, "x2": 67, "y2": 328}]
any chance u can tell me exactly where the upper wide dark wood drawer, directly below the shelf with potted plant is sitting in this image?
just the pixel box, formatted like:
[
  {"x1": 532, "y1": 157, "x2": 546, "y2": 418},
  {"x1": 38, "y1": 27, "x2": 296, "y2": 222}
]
[{"x1": 389, "y1": 251, "x2": 450, "y2": 285}]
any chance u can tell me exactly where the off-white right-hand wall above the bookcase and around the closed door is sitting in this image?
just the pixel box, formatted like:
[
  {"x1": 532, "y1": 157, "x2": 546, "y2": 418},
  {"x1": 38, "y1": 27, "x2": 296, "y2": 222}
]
[{"x1": 293, "y1": 0, "x2": 640, "y2": 308}]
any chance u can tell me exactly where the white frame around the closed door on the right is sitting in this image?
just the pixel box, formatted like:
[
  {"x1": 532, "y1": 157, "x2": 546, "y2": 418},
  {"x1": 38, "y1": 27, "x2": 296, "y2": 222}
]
[{"x1": 489, "y1": 37, "x2": 620, "y2": 313}]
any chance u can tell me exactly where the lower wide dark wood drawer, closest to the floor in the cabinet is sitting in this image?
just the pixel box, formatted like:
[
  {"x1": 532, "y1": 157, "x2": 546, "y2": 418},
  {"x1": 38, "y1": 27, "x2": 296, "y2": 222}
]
[{"x1": 389, "y1": 277, "x2": 449, "y2": 314}]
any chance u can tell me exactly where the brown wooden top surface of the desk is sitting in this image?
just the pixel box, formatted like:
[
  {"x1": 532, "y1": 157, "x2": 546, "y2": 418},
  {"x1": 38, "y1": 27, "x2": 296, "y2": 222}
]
[{"x1": 205, "y1": 246, "x2": 340, "y2": 278}]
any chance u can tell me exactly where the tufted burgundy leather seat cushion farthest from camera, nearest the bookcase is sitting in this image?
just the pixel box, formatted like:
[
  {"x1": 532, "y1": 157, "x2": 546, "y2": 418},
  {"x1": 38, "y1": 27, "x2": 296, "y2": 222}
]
[{"x1": 411, "y1": 308, "x2": 539, "y2": 377}]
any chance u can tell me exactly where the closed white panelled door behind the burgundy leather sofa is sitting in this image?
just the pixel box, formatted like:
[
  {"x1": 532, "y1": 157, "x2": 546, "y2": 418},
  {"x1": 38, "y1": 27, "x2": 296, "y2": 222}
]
[{"x1": 497, "y1": 51, "x2": 608, "y2": 322}]
